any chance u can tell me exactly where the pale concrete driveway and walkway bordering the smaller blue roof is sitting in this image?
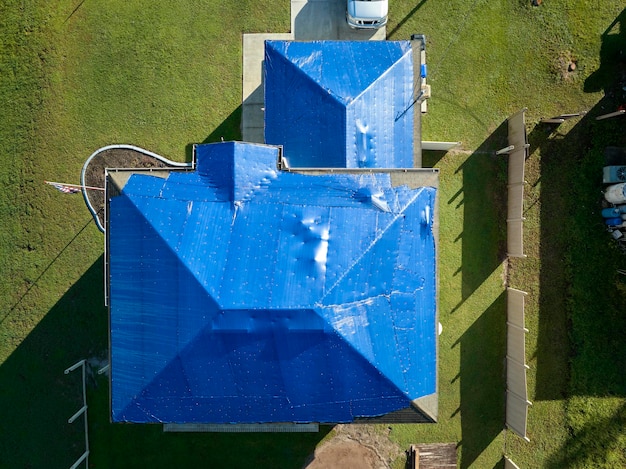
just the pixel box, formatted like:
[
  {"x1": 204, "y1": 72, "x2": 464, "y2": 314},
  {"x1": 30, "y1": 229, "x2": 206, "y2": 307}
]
[{"x1": 241, "y1": 0, "x2": 387, "y2": 143}]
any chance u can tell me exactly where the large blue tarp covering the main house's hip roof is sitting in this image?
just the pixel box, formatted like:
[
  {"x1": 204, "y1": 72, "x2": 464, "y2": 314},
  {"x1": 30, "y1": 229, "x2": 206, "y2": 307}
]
[{"x1": 107, "y1": 142, "x2": 436, "y2": 423}]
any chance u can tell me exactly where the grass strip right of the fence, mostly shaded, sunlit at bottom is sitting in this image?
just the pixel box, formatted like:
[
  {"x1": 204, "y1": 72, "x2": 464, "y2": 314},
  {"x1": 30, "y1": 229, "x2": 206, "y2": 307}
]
[{"x1": 507, "y1": 99, "x2": 626, "y2": 467}]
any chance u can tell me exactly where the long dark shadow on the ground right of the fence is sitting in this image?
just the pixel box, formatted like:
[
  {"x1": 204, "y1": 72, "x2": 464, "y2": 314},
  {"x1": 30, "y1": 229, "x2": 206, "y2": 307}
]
[{"x1": 529, "y1": 6, "x2": 626, "y2": 400}]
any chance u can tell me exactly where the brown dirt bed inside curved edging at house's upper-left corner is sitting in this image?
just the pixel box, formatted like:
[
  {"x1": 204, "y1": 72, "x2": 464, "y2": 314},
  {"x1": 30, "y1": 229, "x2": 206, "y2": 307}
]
[{"x1": 85, "y1": 148, "x2": 172, "y2": 226}]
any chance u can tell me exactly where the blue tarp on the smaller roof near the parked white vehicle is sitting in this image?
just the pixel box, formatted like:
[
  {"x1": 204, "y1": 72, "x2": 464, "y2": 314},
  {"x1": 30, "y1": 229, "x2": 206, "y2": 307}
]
[{"x1": 264, "y1": 41, "x2": 413, "y2": 168}]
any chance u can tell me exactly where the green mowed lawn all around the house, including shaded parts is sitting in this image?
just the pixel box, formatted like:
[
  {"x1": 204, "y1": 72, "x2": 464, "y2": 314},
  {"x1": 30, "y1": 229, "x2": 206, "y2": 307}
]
[{"x1": 0, "y1": 0, "x2": 626, "y2": 468}]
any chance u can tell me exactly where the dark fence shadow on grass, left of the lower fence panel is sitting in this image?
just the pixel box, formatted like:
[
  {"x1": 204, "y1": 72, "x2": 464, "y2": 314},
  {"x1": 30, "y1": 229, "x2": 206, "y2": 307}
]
[{"x1": 455, "y1": 293, "x2": 506, "y2": 468}]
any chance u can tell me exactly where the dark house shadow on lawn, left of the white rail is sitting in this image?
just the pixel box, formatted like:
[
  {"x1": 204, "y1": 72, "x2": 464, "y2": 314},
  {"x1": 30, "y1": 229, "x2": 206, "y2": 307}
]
[{"x1": 0, "y1": 257, "x2": 107, "y2": 467}]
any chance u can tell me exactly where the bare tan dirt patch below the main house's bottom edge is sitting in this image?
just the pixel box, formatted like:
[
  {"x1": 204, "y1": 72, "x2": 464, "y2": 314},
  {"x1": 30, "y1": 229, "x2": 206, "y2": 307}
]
[{"x1": 304, "y1": 425, "x2": 403, "y2": 469}]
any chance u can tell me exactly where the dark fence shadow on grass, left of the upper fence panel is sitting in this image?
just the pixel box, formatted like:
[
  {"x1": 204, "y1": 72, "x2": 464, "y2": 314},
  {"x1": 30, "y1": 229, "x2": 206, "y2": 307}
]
[{"x1": 454, "y1": 122, "x2": 507, "y2": 310}]
